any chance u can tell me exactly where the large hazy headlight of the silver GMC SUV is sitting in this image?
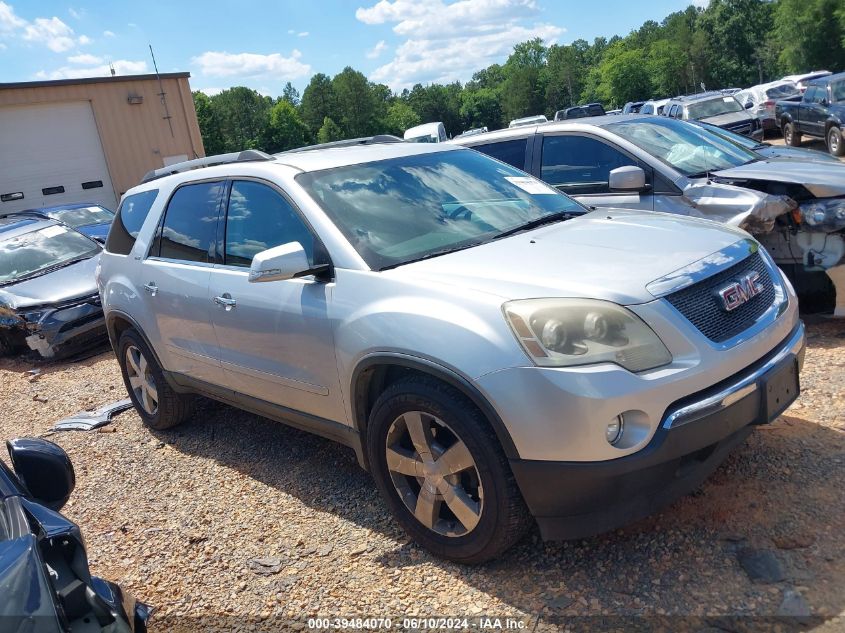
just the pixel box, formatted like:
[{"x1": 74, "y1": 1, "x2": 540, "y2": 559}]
[{"x1": 504, "y1": 299, "x2": 672, "y2": 372}]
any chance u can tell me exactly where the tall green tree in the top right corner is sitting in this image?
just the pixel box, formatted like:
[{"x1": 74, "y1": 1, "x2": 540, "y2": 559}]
[{"x1": 774, "y1": 0, "x2": 845, "y2": 73}]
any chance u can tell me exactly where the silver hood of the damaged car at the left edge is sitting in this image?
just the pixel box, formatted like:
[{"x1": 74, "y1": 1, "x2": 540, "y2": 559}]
[{"x1": 0, "y1": 254, "x2": 100, "y2": 310}]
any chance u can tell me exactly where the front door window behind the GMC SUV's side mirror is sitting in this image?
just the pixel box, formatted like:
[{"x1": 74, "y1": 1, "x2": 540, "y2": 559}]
[{"x1": 226, "y1": 181, "x2": 314, "y2": 266}]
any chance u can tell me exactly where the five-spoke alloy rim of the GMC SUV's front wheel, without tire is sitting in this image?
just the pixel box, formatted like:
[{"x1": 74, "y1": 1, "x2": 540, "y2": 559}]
[{"x1": 385, "y1": 411, "x2": 484, "y2": 537}]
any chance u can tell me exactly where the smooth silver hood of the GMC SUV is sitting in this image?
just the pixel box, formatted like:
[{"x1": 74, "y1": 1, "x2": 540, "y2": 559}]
[{"x1": 392, "y1": 209, "x2": 748, "y2": 305}]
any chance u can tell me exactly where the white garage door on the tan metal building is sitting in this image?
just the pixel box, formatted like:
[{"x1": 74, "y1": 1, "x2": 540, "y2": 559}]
[{"x1": 0, "y1": 101, "x2": 117, "y2": 213}]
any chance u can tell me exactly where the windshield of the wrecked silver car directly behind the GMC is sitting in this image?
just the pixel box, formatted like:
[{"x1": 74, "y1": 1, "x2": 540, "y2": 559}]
[{"x1": 605, "y1": 118, "x2": 760, "y2": 176}]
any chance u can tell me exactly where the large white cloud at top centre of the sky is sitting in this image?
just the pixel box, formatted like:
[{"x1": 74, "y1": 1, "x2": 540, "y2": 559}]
[{"x1": 355, "y1": 0, "x2": 565, "y2": 90}]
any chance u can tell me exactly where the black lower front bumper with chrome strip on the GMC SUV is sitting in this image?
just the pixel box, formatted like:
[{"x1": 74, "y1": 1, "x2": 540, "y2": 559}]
[{"x1": 511, "y1": 323, "x2": 806, "y2": 540}]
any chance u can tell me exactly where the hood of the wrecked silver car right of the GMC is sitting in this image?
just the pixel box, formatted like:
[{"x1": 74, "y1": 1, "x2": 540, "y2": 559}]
[{"x1": 713, "y1": 160, "x2": 845, "y2": 198}]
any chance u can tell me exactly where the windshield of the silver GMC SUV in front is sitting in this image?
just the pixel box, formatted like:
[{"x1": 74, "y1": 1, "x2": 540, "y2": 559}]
[{"x1": 296, "y1": 150, "x2": 585, "y2": 270}]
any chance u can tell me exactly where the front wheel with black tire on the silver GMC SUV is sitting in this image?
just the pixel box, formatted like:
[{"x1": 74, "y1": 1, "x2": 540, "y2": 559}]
[{"x1": 367, "y1": 378, "x2": 530, "y2": 564}]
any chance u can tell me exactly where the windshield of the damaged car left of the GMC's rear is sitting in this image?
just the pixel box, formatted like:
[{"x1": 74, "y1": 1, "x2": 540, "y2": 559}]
[{"x1": 0, "y1": 225, "x2": 100, "y2": 286}]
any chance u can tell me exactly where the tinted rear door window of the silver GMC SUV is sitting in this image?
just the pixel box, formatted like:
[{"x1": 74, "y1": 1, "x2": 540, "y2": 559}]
[{"x1": 153, "y1": 182, "x2": 223, "y2": 262}]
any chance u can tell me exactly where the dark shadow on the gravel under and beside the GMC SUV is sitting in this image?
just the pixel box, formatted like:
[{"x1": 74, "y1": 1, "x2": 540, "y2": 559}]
[{"x1": 156, "y1": 403, "x2": 845, "y2": 631}]
